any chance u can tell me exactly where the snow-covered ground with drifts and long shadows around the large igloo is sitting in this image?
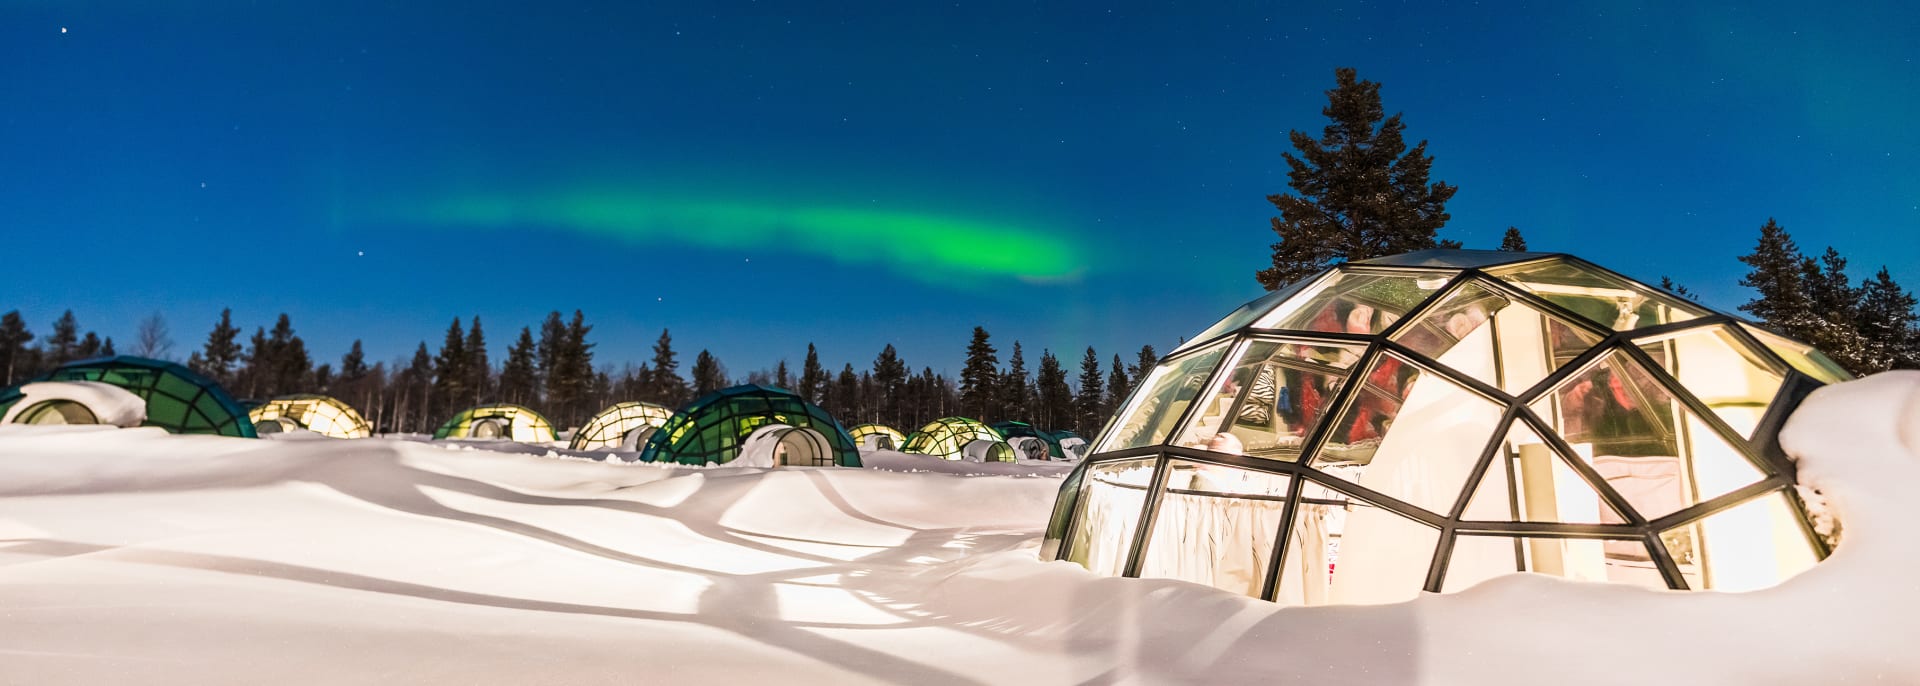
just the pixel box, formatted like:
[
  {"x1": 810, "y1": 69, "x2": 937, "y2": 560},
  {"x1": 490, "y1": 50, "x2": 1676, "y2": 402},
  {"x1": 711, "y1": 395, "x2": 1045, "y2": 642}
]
[{"x1": 0, "y1": 373, "x2": 1920, "y2": 684}]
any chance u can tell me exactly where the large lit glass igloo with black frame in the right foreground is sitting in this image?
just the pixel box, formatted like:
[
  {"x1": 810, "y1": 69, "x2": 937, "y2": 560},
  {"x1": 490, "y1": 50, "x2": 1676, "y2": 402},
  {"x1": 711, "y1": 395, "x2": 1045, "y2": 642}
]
[{"x1": 1043, "y1": 250, "x2": 1847, "y2": 605}]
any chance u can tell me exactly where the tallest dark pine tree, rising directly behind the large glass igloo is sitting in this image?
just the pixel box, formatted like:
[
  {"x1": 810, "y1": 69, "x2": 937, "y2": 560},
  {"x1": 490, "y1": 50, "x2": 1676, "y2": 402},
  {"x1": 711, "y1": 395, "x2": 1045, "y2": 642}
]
[{"x1": 1256, "y1": 67, "x2": 1457, "y2": 290}]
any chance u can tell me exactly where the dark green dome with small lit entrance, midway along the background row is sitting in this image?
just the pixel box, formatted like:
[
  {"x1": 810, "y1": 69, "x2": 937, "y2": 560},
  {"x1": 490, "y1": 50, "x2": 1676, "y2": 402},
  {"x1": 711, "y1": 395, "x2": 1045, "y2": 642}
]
[{"x1": 639, "y1": 384, "x2": 860, "y2": 467}]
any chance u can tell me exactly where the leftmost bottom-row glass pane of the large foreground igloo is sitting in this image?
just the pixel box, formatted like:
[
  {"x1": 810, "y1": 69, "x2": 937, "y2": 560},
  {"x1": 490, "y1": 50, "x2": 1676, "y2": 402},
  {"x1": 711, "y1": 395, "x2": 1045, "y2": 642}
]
[{"x1": 1068, "y1": 457, "x2": 1154, "y2": 576}]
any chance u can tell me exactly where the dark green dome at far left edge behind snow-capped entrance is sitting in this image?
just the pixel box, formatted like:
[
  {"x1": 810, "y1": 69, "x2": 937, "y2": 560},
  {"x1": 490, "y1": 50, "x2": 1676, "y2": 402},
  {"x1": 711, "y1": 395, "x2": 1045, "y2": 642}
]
[{"x1": 0, "y1": 355, "x2": 253, "y2": 438}]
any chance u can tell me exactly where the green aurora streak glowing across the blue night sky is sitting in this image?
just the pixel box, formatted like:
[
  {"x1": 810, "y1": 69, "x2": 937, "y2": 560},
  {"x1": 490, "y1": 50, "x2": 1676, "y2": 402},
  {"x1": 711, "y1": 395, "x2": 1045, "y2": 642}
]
[{"x1": 415, "y1": 194, "x2": 1092, "y2": 284}]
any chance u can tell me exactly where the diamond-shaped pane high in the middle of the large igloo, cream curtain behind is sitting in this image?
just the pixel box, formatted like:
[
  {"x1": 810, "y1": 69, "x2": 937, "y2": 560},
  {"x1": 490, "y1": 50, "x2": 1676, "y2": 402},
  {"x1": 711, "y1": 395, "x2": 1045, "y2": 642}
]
[{"x1": 1394, "y1": 281, "x2": 1601, "y2": 394}]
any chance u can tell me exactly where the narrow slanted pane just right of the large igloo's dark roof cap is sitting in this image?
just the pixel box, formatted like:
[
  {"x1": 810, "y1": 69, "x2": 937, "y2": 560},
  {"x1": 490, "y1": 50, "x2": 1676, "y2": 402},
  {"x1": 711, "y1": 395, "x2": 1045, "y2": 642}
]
[{"x1": 1488, "y1": 257, "x2": 1707, "y2": 331}]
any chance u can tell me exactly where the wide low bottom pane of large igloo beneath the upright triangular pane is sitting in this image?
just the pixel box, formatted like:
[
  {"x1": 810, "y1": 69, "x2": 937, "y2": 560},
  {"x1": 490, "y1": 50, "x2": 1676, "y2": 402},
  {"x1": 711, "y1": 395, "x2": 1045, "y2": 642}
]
[{"x1": 1440, "y1": 534, "x2": 1667, "y2": 594}]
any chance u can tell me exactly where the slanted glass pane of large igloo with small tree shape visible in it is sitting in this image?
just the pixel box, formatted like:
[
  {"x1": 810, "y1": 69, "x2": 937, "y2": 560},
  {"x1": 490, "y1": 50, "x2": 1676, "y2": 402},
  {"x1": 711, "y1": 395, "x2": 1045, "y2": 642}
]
[{"x1": 1175, "y1": 338, "x2": 1367, "y2": 461}]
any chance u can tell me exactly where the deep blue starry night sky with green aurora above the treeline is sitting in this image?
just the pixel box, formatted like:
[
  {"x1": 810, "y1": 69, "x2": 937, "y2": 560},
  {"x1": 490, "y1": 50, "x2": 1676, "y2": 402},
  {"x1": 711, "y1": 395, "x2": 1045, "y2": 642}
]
[{"x1": 0, "y1": 0, "x2": 1920, "y2": 375}]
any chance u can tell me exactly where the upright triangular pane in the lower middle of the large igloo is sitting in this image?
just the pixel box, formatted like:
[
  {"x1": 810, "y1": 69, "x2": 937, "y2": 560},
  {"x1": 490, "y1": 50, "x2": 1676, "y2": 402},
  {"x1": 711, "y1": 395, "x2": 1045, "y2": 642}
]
[{"x1": 1461, "y1": 421, "x2": 1624, "y2": 525}]
